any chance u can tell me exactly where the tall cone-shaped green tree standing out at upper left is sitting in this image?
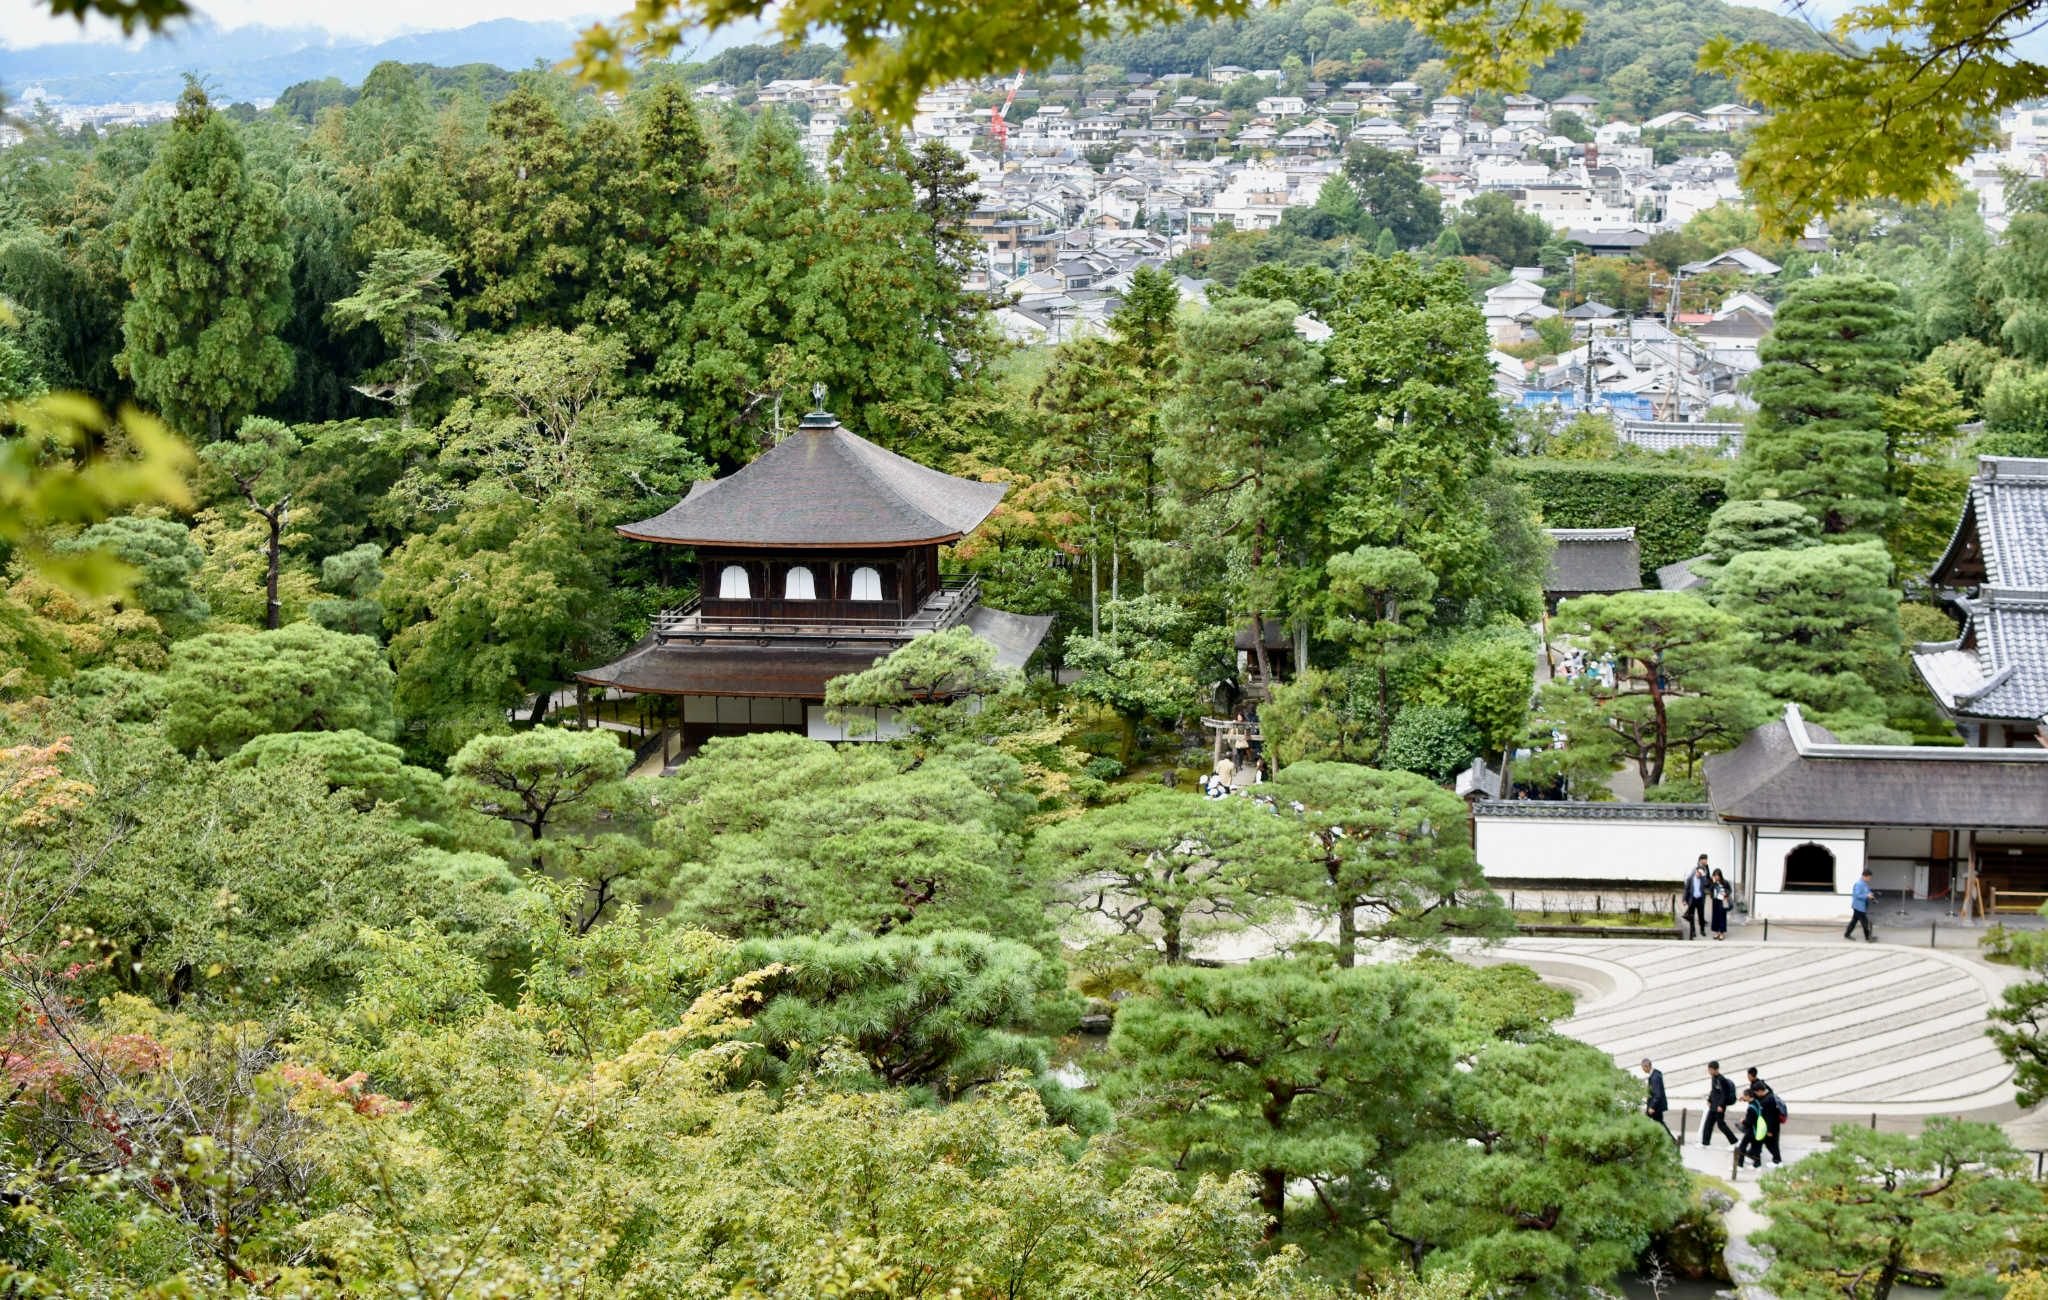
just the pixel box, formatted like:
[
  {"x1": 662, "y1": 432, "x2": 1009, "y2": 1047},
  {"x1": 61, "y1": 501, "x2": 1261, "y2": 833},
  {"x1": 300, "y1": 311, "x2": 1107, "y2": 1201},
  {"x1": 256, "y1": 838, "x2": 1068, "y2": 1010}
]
[{"x1": 117, "y1": 82, "x2": 291, "y2": 438}]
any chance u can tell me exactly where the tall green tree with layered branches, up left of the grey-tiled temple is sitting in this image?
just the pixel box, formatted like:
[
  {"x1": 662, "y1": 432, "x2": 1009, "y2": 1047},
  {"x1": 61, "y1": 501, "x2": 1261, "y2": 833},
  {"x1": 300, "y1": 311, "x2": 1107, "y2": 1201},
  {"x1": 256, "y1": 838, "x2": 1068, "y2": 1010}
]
[{"x1": 1729, "y1": 274, "x2": 1909, "y2": 536}]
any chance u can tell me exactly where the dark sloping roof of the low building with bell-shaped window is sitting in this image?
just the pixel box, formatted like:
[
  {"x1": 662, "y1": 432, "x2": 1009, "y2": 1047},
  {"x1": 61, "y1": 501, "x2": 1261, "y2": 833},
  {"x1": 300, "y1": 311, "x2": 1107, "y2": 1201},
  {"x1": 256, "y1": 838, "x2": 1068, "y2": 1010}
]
[{"x1": 1704, "y1": 706, "x2": 2048, "y2": 829}]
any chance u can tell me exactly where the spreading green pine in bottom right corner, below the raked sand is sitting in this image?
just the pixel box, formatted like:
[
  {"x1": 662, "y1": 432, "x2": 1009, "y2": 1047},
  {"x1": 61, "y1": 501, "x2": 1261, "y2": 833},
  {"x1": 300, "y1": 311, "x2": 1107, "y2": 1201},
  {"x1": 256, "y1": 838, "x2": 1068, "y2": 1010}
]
[{"x1": 1757, "y1": 1116, "x2": 2042, "y2": 1300}]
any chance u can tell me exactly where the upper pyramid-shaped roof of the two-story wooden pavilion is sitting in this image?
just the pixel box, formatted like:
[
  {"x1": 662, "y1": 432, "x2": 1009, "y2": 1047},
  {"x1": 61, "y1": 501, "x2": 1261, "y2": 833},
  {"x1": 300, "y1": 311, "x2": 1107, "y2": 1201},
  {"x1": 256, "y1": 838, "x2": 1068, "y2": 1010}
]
[{"x1": 618, "y1": 411, "x2": 1006, "y2": 547}]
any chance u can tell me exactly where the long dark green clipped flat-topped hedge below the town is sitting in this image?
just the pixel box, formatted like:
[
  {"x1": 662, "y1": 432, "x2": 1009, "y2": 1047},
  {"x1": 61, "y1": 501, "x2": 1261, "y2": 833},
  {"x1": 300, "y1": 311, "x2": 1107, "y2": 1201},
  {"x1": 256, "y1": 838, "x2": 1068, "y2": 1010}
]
[{"x1": 1507, "y1": 457, "x2": 1729, "y2": 588}]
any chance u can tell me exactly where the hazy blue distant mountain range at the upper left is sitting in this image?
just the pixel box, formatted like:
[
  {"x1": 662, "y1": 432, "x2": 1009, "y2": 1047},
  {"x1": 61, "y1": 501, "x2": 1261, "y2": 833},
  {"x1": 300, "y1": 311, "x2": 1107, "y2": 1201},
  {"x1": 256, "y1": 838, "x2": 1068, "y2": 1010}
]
[{"x1": 0, "y1": 14, "x2": 764, "y2": 104}]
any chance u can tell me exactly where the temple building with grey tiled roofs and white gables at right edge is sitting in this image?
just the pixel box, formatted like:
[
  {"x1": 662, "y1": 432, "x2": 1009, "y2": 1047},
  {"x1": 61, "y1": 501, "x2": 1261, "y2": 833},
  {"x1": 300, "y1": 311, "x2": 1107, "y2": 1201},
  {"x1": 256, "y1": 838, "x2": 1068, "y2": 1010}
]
[{"x1": 1913, "y1": 457, "x2": 2048, "y2": 749}]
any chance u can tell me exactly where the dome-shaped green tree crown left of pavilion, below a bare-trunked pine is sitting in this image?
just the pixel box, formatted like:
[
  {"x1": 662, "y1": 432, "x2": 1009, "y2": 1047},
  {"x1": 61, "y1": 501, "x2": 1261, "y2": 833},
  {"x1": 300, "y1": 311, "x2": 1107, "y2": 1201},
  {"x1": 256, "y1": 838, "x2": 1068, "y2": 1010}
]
[{"x1": 164, "y1": 622, "x2": 395, "y2": 755}]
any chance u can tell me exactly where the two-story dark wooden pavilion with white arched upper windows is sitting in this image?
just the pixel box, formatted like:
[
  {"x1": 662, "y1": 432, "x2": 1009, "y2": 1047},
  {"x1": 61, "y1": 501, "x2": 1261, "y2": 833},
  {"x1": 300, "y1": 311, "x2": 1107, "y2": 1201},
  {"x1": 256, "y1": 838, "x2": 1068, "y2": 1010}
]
[{"x1": 578, "y1": 411, "x2": 1053, "y2": 753}]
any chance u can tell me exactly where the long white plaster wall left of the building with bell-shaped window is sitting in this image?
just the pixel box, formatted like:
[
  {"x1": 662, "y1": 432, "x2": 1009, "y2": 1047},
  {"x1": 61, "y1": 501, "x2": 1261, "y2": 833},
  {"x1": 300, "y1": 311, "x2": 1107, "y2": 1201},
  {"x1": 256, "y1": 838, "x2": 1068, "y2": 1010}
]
[{"x1": 1475, "y1": 817, "x2": 1735, "y2": 889}]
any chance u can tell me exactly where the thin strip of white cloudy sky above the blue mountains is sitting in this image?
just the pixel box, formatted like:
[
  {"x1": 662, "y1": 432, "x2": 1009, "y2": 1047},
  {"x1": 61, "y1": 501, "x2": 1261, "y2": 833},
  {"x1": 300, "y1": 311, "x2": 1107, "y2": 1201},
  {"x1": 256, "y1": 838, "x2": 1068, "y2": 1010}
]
[{"x1": 0, "y1": 0, "x2": 1849, "y2": 45}]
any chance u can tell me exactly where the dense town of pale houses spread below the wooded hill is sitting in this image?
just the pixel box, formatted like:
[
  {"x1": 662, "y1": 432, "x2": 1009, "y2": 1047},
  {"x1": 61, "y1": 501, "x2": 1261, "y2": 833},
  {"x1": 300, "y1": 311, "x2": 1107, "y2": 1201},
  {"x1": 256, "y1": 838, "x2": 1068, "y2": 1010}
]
[{"x1": 696, "y1": 66, "x2": 2048, "y2": 421}]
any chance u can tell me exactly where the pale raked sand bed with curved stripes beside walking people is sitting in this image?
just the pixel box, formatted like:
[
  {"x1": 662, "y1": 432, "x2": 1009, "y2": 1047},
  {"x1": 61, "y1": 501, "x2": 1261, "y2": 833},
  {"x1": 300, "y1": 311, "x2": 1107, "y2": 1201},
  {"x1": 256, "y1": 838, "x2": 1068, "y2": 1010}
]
[{"x1": 1483, "y1": 938, "x2": 2019, "y2": 1140}]
